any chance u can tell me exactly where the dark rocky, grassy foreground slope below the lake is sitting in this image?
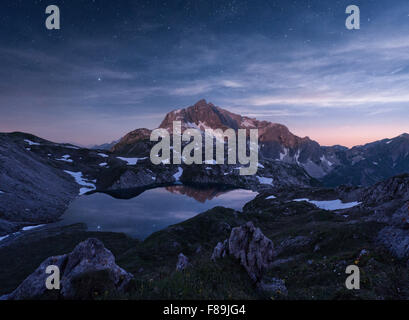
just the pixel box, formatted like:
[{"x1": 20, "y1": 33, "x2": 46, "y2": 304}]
[{"x1": 0, "y1": 175, "x2": 409, "y2": 299}]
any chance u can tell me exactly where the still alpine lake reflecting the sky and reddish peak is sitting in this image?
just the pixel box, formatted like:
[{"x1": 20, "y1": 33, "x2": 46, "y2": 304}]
[{"x1": 58, "y1": 186, "x2": 257, "y2": 239}]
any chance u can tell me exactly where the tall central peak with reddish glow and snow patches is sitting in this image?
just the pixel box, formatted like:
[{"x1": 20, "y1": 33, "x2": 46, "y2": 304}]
[{"x1": 111, "y1": 100, "x2": 339, "y2": 178}]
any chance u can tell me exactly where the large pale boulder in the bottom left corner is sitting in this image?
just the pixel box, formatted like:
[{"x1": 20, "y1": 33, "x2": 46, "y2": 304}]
[{"x1": 1, "y1": 238, "x2": 133, "y2": 300}]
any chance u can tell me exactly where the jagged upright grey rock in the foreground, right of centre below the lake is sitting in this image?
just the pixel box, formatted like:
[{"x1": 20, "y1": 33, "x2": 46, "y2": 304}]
[{"x1": 212, "y1": 221, "x2": 274, "y2": 283}]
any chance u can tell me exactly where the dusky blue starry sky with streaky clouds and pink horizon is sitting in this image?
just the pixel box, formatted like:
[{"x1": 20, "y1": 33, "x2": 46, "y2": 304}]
[{"x1": 0, "y1": 0, "x2": 409, "y2": 146}]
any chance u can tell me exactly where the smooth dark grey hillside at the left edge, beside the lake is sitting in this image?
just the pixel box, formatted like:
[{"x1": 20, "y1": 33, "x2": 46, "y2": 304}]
[{"x1": 0, "y1": 134, "x2": 79, "y2": 232}]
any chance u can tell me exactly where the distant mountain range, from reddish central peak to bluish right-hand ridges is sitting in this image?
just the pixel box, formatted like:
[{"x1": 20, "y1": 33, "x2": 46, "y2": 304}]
[{"x1": 112, "y1": 100, "x2": 409, "y2": 186}]
